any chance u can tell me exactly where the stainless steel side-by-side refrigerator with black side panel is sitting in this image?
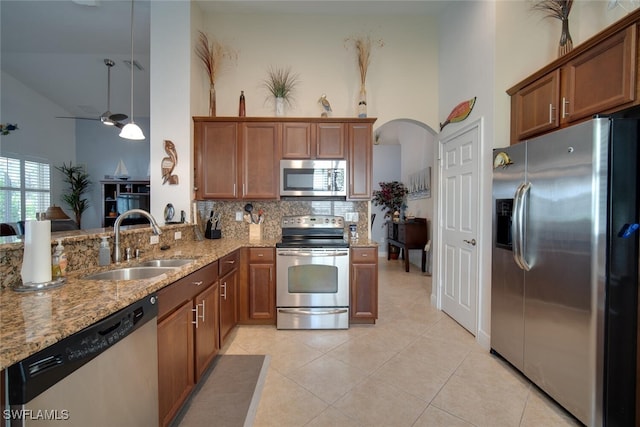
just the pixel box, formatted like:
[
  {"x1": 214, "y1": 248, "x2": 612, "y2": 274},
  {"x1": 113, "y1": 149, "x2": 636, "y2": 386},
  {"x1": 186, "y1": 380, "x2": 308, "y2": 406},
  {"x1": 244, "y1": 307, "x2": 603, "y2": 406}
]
[{"x1": 491, "y1": 114, "x2": 640, "y2": 426}]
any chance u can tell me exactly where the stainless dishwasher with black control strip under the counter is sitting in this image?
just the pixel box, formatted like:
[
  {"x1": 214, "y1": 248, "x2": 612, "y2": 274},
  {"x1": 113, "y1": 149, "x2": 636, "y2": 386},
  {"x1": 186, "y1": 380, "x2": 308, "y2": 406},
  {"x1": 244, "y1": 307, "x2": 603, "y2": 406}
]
[{"x1": 3, "y1": 295, "x2": 158, "y2": 427}]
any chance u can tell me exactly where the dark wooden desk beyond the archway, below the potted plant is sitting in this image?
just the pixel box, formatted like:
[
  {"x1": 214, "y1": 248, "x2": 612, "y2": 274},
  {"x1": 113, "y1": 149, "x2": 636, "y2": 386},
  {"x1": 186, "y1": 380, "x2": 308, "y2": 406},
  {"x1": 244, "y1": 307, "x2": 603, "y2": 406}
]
[{"x1": 387, "y1": 218, "x2": 429, "y2": 273}]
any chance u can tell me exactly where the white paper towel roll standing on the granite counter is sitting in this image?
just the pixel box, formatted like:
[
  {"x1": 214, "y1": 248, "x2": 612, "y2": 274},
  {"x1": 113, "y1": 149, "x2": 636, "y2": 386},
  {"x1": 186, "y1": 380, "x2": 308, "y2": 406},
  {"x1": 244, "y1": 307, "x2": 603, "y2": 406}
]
[{"x1": 21, "y1": 220, "x2": 51, "y2": 283}]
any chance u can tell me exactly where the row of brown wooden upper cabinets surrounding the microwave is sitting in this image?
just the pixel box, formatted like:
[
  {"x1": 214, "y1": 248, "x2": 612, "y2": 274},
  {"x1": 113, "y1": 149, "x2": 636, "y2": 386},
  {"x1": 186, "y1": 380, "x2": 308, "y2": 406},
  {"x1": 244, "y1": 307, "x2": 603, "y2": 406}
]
[{"x1": 193, "y1": 117, "x2": 376, "y2": 200}]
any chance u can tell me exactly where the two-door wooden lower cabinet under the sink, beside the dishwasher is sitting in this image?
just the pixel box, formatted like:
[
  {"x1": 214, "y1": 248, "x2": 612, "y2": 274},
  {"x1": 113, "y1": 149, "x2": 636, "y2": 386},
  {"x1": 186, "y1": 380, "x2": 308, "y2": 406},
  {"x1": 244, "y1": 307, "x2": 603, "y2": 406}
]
[{"x1": 158, "y1": 262, "x2": 220, "y2": 426}]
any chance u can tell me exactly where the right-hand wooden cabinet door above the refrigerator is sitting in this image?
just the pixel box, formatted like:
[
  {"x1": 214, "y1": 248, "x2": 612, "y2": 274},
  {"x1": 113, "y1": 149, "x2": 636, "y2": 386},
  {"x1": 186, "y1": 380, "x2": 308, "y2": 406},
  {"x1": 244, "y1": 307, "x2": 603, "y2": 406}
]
[{"x1": 561, "y1": 25, "x2": 637, "y2": 122}]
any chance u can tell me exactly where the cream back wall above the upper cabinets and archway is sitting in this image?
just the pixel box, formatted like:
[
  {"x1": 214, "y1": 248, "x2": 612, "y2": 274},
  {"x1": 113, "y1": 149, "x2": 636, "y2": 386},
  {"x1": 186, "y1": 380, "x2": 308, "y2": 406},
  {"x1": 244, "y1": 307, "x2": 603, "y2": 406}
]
[{"x1": 199, "y1": 10, "x2": 438, "y2": 127}]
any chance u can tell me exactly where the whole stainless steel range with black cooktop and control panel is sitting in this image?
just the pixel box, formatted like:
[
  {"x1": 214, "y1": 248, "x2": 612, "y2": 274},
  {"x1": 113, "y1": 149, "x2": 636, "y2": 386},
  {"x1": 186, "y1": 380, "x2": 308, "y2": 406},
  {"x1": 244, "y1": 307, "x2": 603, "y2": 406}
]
[{"x1": 276, "y1": 215, "x2": 349, "y2": 329}]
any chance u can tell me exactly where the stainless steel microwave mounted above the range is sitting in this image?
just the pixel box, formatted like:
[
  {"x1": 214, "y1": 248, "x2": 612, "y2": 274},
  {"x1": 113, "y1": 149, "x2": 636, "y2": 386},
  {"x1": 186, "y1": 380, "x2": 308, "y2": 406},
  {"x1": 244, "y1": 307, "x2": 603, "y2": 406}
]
[{"x1": 280, "y1": 160, "x2": 347, "y2": 197}]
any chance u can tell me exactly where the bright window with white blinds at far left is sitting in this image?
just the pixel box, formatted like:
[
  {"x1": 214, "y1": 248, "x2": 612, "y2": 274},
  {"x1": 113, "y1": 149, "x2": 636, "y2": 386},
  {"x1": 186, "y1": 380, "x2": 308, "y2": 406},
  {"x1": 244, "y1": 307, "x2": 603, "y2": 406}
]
[{"x1": 0, "y1": 156, "x2": 51, "y2": 223}]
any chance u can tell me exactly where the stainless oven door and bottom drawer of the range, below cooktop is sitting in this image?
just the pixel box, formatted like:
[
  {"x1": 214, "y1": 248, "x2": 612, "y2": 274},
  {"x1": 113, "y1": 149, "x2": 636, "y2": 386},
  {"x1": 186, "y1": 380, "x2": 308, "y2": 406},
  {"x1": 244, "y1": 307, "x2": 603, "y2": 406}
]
[{"x1": 276, "y1": 248, "x2": 349, "y2": 329}]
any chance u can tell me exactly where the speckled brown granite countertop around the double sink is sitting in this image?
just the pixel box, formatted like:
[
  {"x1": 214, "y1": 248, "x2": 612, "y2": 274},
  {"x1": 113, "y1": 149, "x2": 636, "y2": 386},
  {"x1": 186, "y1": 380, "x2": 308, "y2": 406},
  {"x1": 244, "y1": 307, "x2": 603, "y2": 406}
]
[{"x1": 0, "y1": 238, "x2": 276, "y2": 370}]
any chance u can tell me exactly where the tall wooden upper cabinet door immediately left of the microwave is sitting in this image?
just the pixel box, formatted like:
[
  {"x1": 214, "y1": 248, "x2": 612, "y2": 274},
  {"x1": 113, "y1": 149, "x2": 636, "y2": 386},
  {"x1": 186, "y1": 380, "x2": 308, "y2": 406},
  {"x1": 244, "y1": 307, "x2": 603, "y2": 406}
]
[{"x1": 241, "y1": 122, "x2": 281, "y2": 199}]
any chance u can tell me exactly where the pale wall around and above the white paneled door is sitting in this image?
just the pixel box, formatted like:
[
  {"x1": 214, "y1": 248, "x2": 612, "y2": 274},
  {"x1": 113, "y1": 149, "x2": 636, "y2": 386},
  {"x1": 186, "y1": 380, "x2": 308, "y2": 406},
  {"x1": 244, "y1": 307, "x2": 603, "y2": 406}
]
[{"x1": 432, "y1": 1, "x2": 498, "y2": 348}]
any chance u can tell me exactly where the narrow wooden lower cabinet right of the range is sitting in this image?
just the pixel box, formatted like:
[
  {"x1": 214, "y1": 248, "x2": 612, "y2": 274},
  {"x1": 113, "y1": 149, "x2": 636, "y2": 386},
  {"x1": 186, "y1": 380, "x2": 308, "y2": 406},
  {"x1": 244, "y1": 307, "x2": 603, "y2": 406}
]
[{"x1": 349, "y1": 247, "x2": 378, "y2": 323}]
